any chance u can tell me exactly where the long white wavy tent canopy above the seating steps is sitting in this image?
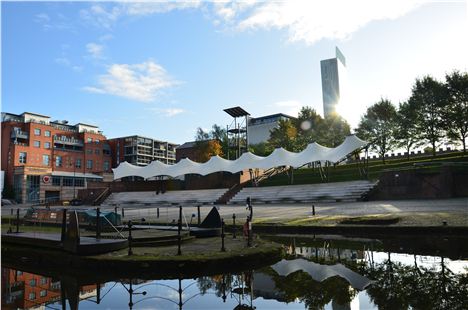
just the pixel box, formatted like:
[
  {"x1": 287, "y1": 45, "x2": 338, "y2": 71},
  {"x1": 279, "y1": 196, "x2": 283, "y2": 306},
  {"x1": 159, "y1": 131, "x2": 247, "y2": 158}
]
[{"x1": 112, "y1": 135, "x2": 367, "y2": 180}]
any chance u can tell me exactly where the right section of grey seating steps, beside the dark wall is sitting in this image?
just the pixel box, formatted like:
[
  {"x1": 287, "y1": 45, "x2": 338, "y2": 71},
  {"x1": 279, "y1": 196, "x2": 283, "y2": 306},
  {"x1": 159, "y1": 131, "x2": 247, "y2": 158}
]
[{"x1": 229, "y1": 181, "x2": 376, "y2": 204}]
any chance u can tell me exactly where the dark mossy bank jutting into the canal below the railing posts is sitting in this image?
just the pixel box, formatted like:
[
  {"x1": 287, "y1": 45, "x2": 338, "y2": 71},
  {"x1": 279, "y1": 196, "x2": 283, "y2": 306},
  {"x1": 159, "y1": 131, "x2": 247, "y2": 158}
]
[{"x1": 2, "y1": 236, "x2": 283, "y2": 278}]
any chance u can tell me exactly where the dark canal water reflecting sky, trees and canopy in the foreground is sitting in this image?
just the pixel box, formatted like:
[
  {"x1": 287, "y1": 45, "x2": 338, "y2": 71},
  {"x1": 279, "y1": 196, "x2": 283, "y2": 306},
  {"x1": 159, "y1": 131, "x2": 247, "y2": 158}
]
[{"x1": 2, "y1": 236, "x2": 468, "y2": 310}]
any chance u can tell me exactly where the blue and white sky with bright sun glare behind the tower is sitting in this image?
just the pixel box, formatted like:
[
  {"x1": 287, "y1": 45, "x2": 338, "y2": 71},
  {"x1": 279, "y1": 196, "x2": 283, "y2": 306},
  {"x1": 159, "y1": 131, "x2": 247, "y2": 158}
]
[{"x1": 1, "y1": 0, "x2": 468, "y2": 144}]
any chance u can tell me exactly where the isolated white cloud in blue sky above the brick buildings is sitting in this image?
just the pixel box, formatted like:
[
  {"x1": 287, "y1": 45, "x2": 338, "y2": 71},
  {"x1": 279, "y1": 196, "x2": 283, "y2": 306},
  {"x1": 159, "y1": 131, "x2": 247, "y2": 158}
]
[{"x1": 83, "y1": 60, "x2": 179, "y2": 102}]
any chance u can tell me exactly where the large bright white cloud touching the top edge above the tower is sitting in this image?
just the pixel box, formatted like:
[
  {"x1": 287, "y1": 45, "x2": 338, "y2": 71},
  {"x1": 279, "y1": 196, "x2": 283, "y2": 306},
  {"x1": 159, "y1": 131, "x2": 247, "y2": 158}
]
[{"x1": 237, "y1": 0, "x2": 424, "y2": 44}]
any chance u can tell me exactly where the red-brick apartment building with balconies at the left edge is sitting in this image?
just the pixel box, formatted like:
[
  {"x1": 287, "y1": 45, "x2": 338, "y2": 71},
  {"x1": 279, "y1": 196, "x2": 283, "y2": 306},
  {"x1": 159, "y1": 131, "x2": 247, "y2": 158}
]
[{"x1": 1, "y1": 112, "x2": 112, "y2": 203}]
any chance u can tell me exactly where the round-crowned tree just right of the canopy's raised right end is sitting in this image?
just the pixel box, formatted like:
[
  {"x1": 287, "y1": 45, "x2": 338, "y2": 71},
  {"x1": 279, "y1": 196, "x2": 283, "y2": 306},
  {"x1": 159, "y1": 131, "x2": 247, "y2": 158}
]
[{"x1": 356, "y1": 99, "x2": 397, "y2": 163}]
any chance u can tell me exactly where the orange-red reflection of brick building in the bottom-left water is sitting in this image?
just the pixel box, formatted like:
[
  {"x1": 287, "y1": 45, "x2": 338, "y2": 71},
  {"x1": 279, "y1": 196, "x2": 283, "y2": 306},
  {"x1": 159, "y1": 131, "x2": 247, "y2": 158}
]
[{"x1": 2, "y1": 268, "x2": 96, "y2": 309}]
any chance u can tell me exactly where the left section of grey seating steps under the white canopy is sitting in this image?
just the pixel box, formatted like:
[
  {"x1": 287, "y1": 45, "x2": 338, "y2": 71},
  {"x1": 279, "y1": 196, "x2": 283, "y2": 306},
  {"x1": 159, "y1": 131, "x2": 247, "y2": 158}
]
[{"x1": 102, "y1": 188, "x2": 228, "y2": 206}]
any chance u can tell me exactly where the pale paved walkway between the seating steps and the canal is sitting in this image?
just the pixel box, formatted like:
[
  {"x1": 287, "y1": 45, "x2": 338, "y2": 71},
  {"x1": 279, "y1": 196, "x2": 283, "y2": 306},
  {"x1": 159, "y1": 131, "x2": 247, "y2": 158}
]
[{"x1": 2, "y1": 198, "x2": 468, "y2": 223}]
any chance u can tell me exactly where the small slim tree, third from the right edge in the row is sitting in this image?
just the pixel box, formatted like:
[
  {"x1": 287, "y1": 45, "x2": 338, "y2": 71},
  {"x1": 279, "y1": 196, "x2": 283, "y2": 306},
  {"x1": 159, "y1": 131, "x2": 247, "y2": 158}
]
[{"x1": 393, "y1": 102, "x2": 421, "y2": 160}]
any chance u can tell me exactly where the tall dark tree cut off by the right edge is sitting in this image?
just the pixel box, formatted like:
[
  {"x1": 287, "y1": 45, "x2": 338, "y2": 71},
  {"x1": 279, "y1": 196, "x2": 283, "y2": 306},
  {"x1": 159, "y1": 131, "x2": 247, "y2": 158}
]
[{"x1": 442, "y1": 71, "x2": 468, "y2": 154}]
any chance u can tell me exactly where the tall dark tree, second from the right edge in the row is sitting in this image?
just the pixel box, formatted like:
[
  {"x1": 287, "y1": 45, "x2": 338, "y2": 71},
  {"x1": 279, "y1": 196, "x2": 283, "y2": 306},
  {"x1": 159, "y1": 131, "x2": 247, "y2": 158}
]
[{"x1": 409, "y1": 76, "x2": 447, "y2": 156}]
